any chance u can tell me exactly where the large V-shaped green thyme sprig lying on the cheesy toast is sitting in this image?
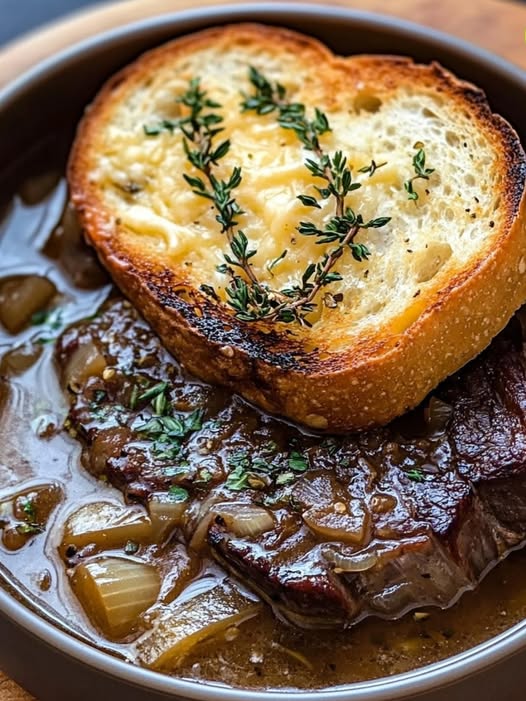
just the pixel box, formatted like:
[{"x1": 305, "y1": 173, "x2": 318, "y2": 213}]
[{"x1": 150, "y1": 74, "x2": 390, "y2": 326}]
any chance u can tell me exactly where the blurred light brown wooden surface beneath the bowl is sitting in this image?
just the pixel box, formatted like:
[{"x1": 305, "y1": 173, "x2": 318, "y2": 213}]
[{"x1": 0, "y1": 0, "x2": 526, "y2": 701}]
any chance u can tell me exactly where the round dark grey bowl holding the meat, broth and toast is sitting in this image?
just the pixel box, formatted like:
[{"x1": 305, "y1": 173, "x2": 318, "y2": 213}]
[{"x1": 0, "y1": 4, "x2": 526, "y2": 701}]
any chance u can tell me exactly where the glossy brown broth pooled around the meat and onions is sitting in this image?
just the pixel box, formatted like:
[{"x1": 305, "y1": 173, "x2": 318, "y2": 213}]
[{"x1": 0, "y1": 142, "x2": 526, "y2": 688}]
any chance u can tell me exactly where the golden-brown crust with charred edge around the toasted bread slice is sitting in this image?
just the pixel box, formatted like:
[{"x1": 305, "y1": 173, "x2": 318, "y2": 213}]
[{"x1": 68, "y1": 25, "x2": 526, "y2": 432}]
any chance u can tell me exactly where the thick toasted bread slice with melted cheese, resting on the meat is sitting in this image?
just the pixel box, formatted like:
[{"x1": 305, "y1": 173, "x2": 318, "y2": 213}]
[{"x1": 69, "y1": 25, "x2": 526, "y2": 432}]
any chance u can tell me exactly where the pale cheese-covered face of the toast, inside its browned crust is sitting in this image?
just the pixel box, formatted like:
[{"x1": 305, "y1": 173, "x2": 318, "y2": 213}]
[{"x1": 90, "y1": 49, "x2": 506, "y2": 346}]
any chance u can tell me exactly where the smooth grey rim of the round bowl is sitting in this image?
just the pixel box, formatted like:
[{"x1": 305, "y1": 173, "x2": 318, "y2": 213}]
[{"x1": 0, "y1": 1, "x2": 526, "y2": 701}]
